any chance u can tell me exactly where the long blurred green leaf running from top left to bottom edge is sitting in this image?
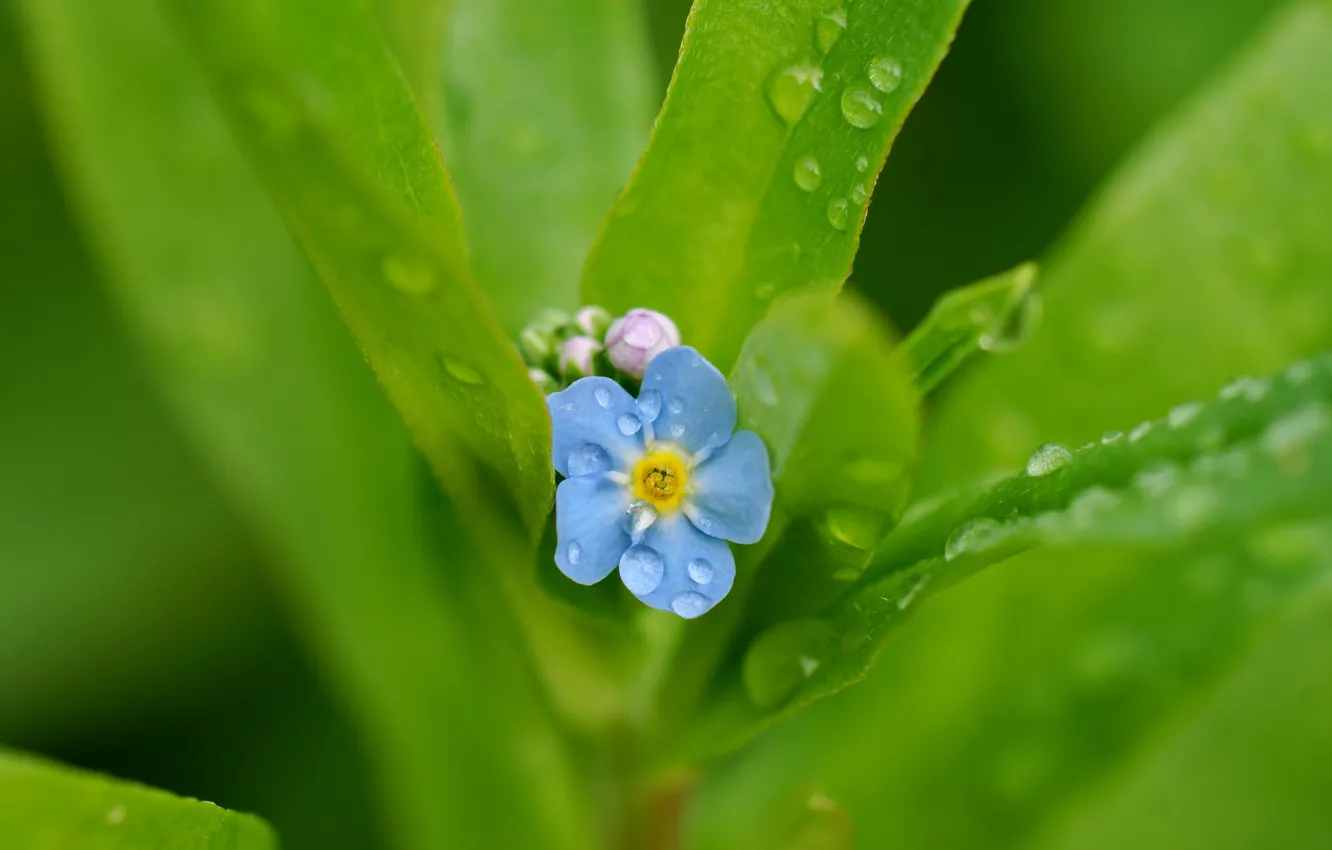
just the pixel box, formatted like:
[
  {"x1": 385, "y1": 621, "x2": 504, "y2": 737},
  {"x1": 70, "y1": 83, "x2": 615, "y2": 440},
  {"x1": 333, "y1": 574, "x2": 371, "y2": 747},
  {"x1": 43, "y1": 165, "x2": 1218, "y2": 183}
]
[{"x1": 23, "y1": 0, "x2": 590, "y2": 849}]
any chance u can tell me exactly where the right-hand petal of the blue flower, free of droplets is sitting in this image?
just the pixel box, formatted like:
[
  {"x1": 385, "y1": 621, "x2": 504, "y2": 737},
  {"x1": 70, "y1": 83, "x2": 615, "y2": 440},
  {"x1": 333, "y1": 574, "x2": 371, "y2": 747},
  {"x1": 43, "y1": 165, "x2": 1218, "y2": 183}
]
[{"x1": 685, "y1": 430, "x2": 773, "y2": 544}]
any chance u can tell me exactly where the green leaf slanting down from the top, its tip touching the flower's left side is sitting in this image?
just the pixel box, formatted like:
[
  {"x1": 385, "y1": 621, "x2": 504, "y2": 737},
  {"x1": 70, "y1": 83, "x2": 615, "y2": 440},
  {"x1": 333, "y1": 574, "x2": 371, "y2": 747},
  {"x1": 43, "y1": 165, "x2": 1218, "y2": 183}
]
[{"x1": 163, "y1": 0, "x2": 553, "y2": 540}]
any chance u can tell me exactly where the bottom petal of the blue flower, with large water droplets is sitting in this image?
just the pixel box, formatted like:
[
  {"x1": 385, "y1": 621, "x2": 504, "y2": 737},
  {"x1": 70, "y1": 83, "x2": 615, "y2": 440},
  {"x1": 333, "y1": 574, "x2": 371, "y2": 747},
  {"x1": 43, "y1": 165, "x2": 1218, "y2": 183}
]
[{"x1": 618, "y1": 511, "x2": 735, "y2": 620}]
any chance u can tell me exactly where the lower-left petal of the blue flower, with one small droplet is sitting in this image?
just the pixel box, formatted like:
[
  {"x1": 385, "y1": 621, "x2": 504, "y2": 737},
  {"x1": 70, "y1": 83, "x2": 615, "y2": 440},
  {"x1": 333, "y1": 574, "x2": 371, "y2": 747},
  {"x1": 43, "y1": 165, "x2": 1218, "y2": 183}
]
[{"x1": 555, "y1": 474, "x2": 630, "y2": 585}]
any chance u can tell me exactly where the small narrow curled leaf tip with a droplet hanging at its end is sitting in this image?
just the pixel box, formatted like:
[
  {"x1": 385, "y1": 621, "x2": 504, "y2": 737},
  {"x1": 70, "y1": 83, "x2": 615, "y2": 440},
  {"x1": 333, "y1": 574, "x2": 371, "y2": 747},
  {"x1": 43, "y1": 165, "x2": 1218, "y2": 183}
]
[{"x1": 902, "y1": 262, "x2": 1042, "y2": 393}]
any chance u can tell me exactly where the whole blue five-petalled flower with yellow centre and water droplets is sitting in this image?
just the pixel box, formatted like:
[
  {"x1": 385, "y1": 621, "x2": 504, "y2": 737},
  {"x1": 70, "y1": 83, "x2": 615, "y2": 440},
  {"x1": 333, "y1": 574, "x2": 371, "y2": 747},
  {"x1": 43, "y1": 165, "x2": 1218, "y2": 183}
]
[{"x1": 546, "y1": 346, "x2": 773, "y2": 618}]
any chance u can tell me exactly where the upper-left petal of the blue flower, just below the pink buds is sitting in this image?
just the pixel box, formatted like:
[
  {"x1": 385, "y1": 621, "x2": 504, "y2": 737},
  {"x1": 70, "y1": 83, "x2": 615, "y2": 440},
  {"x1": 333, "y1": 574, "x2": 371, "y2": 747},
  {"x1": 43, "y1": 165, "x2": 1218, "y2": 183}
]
[{"x1": 546, "y1": 377, "x2": 643, "y2": 477}]
